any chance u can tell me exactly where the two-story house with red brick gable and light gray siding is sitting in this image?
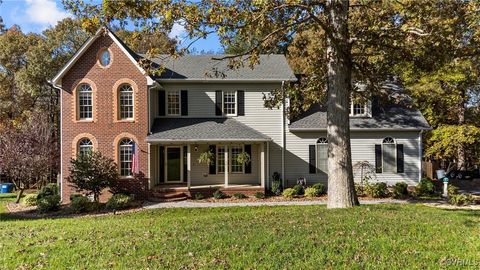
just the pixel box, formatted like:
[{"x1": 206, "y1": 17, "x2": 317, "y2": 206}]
[{"x1": 52, "y1": 28, "x2": 429, "y2": 201}]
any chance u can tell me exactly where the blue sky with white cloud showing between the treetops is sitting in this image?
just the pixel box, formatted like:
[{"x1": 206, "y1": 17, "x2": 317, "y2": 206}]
[{"x1": 0, "y1": 0, "x2": 221, "y2": 53}]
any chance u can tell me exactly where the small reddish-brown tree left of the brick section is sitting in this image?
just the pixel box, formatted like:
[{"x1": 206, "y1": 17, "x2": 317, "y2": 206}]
[{"x1": 0, "y1": 112, "x2": 56, "y2": 203}]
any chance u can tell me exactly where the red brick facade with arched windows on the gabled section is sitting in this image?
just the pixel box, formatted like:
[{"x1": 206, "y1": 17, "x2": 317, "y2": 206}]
[{"x1": 61, "y1": 35, "x2": 149, "y2": 203}]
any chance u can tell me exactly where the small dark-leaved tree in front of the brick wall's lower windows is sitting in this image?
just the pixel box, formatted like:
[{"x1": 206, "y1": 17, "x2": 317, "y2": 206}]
[{"x1": 67, "y1": 152, "x2": 118, "y2": 202}]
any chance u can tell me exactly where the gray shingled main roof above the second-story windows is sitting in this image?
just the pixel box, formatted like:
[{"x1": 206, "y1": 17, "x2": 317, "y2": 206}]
[{"x1": 142, "y1": 54, "x2": 296, "y2": 81}]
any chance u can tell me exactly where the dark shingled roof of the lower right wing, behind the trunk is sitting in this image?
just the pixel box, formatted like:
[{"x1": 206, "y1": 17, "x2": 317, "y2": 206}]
[{"x1": 289, "y1": 102, "x2": 431, "y2": 131}]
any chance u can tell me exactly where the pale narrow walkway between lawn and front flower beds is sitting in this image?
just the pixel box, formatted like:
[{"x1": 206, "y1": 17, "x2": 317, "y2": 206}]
[{"x1": 143, "y1": 199, "x2": 409, "y2": 209}]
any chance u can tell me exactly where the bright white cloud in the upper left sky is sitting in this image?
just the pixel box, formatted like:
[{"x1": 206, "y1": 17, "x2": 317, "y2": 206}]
[{"x1": 25, "y1": 0, "x2": 71, "y2": 27}]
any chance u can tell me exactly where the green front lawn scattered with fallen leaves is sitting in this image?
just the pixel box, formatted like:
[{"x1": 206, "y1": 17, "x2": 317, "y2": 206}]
[{"x1": 0, "y1": 205, "x2": 480, "y2": 269}]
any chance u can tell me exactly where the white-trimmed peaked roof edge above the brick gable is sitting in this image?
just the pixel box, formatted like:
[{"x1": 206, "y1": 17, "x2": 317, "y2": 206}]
[{"x1": 50, "y1": 27, "x2": 154, "y2": 87}]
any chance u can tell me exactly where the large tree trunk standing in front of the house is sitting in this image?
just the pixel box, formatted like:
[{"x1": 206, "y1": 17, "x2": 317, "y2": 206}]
[{"x1": 326, "y1": 0, "x2": 358, "y2": 208}]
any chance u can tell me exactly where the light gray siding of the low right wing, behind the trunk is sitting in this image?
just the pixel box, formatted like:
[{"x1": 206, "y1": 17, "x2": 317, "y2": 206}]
[{"x1": 285, "y1": 131, "x2": 420, "y2": 185}]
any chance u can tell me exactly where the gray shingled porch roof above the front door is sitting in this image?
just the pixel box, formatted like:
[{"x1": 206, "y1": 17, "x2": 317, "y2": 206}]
[{"x1": 147, "y1": 118, "x2": 271, "y2": 142}]
